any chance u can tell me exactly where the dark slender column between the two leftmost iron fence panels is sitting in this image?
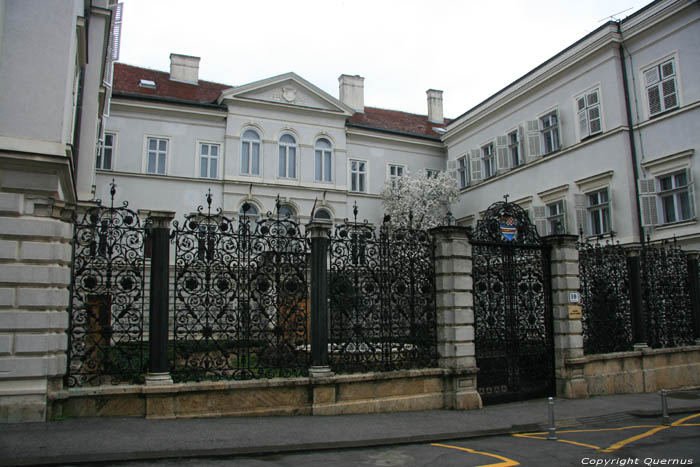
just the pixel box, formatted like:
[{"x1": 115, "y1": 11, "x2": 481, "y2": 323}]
[{"x1": 146, "y1": 211, "x2": 175, "y2": 385}]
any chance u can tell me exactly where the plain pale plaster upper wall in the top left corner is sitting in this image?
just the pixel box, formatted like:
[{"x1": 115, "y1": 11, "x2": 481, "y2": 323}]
[{"x1": 0, "y1": 0, "x2": 83, "y2": 143}]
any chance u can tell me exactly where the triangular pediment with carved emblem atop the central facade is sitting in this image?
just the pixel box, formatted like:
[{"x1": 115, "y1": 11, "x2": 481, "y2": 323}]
[{"x1": 219, "y1": 73, "x2": 354, "y2": 116}]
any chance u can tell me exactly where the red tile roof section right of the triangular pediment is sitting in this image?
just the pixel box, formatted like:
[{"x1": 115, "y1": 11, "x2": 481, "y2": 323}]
[{"x1": 348, "y1": 107, "x2": 451, "y2": 138}]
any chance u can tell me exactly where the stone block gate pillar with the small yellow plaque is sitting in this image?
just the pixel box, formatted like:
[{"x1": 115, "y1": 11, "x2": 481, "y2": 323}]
[{"x1": 545, "y1": 235, "x2": 588, "y2": 398}]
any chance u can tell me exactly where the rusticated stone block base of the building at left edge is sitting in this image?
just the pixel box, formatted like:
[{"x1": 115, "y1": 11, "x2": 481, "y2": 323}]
[{"x1": 0, "y1": 192, "x2": 73, "y2": 422}]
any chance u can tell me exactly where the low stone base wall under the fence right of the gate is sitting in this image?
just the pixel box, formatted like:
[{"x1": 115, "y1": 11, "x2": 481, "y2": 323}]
[{"x1": 560, "y1": 345, "x2": 700, "y2": 397}]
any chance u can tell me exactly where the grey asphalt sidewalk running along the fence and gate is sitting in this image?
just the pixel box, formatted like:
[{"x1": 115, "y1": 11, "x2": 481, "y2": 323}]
[{"x1": 0, "y1": 390, "x2": 700, "y2": 466}]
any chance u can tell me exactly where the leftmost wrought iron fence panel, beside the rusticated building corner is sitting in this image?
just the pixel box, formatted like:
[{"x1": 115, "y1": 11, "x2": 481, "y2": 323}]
[{"x1": 65, "y1": 182, "x2": 147, "y2": 387}]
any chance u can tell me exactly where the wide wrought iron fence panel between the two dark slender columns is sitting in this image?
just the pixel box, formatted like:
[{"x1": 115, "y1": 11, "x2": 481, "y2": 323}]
[{"x1": 171, "y1": 193, "x2": 310, "y2": 381}]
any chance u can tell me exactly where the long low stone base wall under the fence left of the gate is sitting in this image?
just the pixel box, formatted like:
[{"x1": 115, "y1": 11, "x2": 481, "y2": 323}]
[{"x1": 49, "y1": 368, "x2": 454, "y2": 419}]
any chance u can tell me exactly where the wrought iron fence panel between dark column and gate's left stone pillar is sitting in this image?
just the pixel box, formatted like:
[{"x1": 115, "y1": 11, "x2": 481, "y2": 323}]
[{"x1": 328, "y1": 210, "x2": 437, "y2": 373}]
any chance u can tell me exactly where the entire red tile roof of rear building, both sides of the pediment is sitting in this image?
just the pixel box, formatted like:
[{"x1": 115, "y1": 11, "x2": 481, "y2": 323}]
[{"x1": 113, "y1": 63, "x2": 451, "y2": 139}]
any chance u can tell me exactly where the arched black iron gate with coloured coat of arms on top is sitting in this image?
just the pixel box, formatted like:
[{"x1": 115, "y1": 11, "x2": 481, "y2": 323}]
[{"x1": 471, "y1": 201, "x2": 554, "y2": 403}]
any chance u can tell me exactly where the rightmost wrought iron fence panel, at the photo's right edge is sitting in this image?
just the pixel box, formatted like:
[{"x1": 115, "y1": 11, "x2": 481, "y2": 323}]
[{"x1": 640, "y1": 242, "x2": 694, "y2": 347}]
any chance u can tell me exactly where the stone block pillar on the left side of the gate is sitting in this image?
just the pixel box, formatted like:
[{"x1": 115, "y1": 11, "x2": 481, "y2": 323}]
[{"x1": 431, "y1": 226, "x2": 482, "y2": 409}]
